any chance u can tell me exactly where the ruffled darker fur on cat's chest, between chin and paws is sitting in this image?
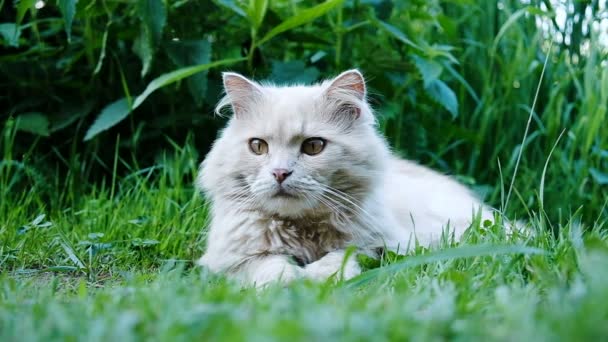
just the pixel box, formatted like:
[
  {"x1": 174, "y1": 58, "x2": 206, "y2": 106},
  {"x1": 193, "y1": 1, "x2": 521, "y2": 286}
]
[{"x1": 262, "y1": 217, "x2": 347, "y2": 264}]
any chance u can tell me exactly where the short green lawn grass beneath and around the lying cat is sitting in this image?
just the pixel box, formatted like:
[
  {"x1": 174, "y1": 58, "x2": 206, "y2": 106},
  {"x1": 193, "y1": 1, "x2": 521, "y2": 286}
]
[{"x1": 0, "y1": 138, "x2": 608, "y2": 341}]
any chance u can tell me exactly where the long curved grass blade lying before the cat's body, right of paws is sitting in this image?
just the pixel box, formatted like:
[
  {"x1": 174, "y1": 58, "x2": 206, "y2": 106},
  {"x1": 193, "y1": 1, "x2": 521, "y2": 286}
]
[{"x1": 344, "y1": 244, "x2": 546, "y2": 287}]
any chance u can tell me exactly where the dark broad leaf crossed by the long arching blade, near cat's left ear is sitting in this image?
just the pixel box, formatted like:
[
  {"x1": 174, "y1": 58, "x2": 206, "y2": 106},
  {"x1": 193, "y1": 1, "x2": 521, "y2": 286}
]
[{"x1": 166, "y1": 39, "x2": 211, "y2": 106}]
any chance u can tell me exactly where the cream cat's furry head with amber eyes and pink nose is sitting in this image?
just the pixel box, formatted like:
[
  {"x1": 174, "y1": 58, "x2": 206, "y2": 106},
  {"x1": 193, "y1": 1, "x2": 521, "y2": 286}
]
[{"x1": 198, "y1": 70, "x2": 388, "y2": 217}]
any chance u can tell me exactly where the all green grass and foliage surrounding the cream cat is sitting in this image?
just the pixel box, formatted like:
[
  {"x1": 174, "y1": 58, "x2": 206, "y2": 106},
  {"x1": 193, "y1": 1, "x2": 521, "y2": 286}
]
[{"x1": 0, "y1": 0, "x2": 608, "y2": 341}]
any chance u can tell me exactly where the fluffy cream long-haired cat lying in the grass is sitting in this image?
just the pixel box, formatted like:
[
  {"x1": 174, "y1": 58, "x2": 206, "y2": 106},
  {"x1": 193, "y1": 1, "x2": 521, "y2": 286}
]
[{"x1": 196, "y1": 70, "x2": 493, "y2": 286}]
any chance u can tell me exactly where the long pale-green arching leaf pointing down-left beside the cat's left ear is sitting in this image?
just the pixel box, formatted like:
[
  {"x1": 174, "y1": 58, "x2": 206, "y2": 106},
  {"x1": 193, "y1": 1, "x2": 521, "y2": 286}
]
[{"x1": 84, "y1": 58, "x2": 246, "y2": 141}]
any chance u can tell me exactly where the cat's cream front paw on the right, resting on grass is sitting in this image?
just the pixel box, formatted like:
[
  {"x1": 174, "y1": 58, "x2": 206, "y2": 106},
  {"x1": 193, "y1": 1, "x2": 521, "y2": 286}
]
[{"x1": 304, "y1": 250, "x2": 361, "y2": 281}]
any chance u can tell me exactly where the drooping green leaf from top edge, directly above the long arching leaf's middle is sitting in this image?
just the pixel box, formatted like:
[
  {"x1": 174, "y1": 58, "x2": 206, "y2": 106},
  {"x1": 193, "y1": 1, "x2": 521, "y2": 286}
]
[{"x1": 133, "y1": 0, "x2": 167, "y2": 77}]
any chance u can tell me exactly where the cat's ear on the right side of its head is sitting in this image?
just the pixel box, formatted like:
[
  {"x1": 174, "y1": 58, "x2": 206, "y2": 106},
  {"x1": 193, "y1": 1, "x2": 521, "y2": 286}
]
[{"x1": 326, "y1": 69, "x2": 366, "y2": 119}]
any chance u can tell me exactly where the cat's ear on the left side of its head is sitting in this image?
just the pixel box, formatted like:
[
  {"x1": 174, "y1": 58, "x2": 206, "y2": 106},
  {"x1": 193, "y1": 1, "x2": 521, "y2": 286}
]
[{"x1": 222, "y1": 72, "x2": 262, "y2": 118}]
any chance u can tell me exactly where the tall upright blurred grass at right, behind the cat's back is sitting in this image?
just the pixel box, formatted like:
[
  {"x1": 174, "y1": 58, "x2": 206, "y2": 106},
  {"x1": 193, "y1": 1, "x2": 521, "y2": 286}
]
[{"x1": 440, "y1": 2, "x2": 608, "y2": 222}]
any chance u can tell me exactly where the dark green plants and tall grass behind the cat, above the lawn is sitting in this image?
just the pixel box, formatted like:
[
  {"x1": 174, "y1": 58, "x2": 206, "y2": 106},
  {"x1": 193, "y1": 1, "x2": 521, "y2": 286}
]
[{"x1": 0, "y1": 0, "x2": 608, "y2": 225}]
